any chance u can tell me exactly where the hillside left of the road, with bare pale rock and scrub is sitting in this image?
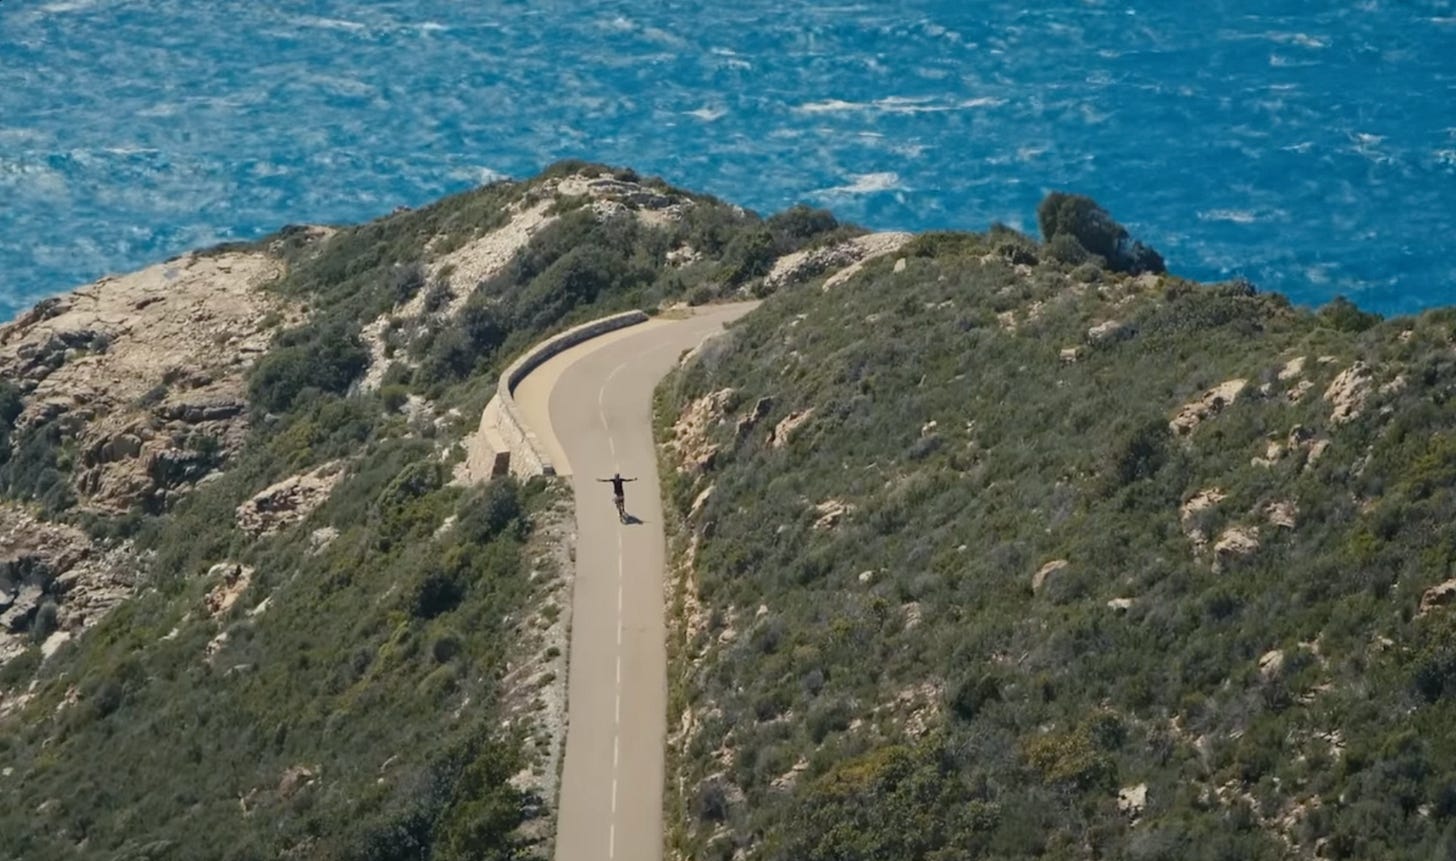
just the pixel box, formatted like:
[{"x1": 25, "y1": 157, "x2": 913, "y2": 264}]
[{"x1": 0, "y1": 163, "x2": 859, "y2": 861}]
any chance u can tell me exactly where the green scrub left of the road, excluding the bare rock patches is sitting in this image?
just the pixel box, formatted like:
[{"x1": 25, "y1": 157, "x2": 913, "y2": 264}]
[{"x1": 0, "y1": 163, "x2": 844, "y2": 861}]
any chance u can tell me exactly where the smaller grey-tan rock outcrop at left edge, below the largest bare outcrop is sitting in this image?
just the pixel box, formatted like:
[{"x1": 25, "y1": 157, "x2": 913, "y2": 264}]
[{"x1": 0, "y1": 503, "x2": 140, "y2": 664}]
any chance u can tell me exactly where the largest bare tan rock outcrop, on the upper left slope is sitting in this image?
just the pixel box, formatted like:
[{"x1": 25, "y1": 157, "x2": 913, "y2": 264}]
[{"x1": 0, "y1": 252, "x2": 297, "y2": 513}]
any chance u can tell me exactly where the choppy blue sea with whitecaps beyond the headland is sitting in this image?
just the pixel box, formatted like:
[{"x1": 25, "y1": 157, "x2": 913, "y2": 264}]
[{"x1": 0, "y1": 0, "x2": 1456, "y2": 319}]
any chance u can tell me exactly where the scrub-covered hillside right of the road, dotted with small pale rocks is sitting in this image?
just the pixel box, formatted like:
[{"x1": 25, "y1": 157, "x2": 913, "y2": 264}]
[{"x1": 658, "y1": 225, "x2": 1456, "y2": 861}]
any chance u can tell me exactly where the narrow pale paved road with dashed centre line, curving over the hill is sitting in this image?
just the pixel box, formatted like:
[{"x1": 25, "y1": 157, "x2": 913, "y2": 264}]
[{"x1": 515, "y1": 303, "x2": 753, "y2": 861}]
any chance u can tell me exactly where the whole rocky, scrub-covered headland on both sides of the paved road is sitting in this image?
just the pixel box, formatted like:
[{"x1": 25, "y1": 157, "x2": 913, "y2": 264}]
[{"x1": 0, "y1": 163, "x2": 1456, "y2": 861}]
